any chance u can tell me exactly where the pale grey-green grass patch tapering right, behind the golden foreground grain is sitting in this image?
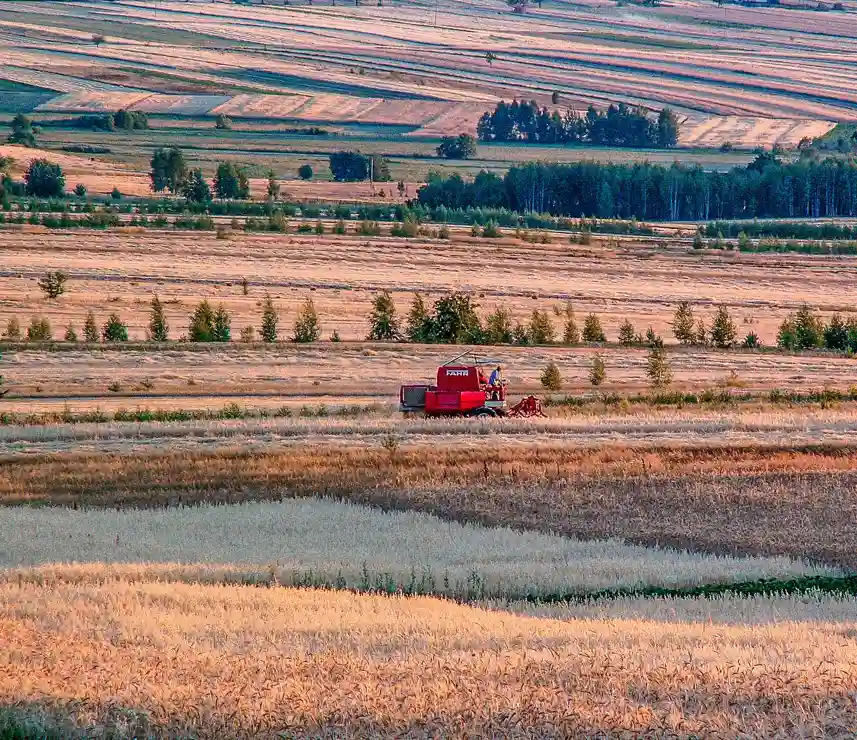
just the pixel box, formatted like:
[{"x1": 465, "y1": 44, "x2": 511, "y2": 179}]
[{"x1": 0, "y1": 494, "x2": 838, "y2": 599}]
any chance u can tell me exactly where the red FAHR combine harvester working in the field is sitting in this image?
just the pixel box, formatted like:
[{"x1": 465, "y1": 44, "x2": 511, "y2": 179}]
[{"x1": 399, "y1": 352, "x2": 544, "y2": 417}]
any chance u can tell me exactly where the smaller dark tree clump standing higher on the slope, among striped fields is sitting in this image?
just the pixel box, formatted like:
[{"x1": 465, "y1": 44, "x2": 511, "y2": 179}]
[{"x1": 476, "y1": 100, "x2": 679, "y2": 149}]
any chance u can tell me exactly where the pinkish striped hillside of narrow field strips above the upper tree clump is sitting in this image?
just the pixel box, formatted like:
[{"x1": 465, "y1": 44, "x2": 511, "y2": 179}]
[{"x1": 0, "y1": 1, "x2": 857, "y2": 129}]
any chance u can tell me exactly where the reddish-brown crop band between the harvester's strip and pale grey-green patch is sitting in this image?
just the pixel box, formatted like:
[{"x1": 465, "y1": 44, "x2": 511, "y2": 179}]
[{"x1": 5, "y1": 438, "x2": 857, "y2": 569}]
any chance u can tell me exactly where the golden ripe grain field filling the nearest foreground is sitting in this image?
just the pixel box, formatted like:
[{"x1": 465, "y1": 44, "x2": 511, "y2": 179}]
[{"x1": 0, "y1": 580, "x2": 857, "y2": 738}]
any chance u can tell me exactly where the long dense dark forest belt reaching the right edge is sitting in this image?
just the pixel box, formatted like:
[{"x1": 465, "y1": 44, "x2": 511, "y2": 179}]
[{"x1": 417, "y1": 153, "x2": 857, "y2": 221}]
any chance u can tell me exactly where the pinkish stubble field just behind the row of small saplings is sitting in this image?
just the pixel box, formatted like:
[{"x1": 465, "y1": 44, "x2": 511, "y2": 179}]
[{"x1": 6, "y1": 228, "x2": 857, "y2": 350}]
